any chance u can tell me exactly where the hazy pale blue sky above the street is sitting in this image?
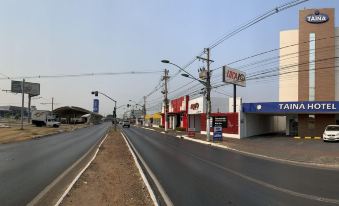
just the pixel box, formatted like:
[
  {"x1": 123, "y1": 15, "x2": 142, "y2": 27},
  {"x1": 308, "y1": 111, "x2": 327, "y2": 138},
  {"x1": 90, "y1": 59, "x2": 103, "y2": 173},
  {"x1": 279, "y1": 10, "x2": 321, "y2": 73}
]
[{"x1": 0, "y1": 0, "x2": 339, "y2": 115}]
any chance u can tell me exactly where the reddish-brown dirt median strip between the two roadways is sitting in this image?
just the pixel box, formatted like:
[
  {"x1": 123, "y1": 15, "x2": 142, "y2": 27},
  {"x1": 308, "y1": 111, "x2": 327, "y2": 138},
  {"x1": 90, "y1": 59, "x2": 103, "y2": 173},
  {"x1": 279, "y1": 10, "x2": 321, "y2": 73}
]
[{"x1": 61, "y1": 131, "x2": 153, "y2": 206}]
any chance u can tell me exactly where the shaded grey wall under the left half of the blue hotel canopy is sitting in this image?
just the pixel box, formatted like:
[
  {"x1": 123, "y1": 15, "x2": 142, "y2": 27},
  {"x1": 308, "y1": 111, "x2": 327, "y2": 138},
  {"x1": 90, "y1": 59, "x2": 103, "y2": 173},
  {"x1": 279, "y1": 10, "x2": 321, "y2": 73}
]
[{"x1": 241, "y1": 114, "x2": 286, "y2": 137}]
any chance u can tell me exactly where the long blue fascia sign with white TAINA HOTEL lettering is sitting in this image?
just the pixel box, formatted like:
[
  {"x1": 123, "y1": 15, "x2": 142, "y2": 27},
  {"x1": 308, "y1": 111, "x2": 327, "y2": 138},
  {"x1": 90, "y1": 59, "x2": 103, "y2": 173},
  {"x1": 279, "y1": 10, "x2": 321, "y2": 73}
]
[{"x1": 242, "y1": 101, "x2": 339, "y2": 114}]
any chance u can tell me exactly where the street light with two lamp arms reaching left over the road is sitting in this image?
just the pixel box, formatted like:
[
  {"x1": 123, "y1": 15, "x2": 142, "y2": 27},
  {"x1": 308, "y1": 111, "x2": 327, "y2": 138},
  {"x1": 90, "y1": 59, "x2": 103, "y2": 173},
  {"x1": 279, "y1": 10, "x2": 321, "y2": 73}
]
[{"x1": 161, "y1": 59, "x2": 211, "y2": 141}]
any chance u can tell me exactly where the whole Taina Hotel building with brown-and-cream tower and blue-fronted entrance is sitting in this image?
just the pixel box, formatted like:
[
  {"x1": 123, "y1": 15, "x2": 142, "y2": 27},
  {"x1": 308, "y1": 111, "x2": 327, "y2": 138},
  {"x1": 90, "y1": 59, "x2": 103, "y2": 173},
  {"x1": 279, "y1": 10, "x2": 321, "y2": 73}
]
[{"x1": 242, "y1": 8, "x2": 339, "y2": 137}]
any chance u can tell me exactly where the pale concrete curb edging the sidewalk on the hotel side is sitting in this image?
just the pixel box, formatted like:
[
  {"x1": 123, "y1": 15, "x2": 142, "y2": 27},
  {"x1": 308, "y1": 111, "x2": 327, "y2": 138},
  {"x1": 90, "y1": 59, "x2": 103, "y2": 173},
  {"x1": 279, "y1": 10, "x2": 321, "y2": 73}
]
[{"x1": 141, "y1": 127, "x2": 339, "y2": 170}]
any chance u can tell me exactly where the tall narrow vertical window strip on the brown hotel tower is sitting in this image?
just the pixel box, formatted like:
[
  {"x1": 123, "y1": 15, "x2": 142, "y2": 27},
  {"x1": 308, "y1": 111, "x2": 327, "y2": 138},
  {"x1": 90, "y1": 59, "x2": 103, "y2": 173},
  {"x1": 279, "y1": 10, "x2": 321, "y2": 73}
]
[{"x1": 308, "y1": 33, "x2": 315, "y2": 101}]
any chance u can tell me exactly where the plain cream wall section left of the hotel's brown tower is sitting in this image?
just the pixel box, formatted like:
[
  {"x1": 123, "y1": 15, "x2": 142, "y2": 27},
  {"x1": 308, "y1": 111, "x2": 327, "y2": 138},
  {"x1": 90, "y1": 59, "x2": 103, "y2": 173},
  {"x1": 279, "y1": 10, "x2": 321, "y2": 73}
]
[{"x1": 279, "y1": 30, "x2": 299, "y2": 102}]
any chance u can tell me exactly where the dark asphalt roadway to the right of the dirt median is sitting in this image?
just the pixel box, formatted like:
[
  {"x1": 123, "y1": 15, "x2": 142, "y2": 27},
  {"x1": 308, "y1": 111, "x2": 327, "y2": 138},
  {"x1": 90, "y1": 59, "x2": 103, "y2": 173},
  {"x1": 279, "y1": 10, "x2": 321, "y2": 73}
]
[{"x1": 124, "y1": 127, "x2": 339, "y2": 206}]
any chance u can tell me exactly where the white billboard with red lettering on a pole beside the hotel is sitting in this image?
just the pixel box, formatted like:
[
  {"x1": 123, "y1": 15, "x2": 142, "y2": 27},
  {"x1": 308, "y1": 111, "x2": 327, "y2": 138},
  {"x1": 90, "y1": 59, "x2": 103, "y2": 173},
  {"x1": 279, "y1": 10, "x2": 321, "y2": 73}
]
[{"x1": 222, "y1": 66, "x2": 246, "y2": 87}]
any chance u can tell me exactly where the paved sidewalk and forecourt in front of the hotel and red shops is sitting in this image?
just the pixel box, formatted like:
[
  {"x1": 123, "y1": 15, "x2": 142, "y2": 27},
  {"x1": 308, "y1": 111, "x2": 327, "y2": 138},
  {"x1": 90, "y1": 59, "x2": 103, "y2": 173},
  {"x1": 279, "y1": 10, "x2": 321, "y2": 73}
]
[{"x1": 139, "y1": 125, "x2": 339, "y2": 168}]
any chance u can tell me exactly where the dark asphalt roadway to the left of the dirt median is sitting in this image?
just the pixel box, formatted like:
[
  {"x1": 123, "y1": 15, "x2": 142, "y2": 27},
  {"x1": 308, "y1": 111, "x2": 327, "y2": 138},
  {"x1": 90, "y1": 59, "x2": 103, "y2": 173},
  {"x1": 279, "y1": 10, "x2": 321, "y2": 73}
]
[{"x1": 0, "y1": 123, "x2": 110, "y2": 206}]
